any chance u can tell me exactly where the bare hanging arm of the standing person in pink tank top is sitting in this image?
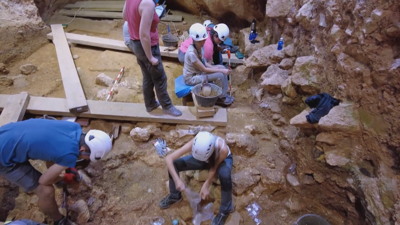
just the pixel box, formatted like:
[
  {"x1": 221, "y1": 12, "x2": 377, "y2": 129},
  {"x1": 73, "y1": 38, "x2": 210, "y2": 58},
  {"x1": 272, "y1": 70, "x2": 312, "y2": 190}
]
[{"x1": 139, "y1": 0, "x2": 158, "y2": 66}]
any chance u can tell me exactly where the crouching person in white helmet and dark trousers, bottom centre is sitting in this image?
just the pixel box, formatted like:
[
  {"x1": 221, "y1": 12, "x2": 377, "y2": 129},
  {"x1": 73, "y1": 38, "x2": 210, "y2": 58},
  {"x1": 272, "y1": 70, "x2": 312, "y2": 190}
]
[{"x1": 159, "y1": 132, "x2": 233, "y2": 225}]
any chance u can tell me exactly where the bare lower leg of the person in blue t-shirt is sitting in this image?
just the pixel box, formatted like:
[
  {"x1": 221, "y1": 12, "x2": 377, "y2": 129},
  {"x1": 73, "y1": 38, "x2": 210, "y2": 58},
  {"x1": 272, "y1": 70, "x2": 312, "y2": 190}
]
[{"x1": 33, "y1": 184, "x2": 63, "y2": 221}]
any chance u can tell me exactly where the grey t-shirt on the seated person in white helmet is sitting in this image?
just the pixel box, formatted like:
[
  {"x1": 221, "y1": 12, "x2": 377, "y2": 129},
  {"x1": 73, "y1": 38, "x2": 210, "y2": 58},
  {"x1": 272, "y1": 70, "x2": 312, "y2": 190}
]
[{"x1": 183, "y1": 45, "x2": 204, "y2": 83}]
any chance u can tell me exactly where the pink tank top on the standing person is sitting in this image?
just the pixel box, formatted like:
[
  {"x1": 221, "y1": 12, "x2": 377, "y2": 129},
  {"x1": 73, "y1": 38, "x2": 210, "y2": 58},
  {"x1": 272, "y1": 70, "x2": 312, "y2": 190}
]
[{"x1": 125, "y1": 0, "x2": 160, "y2": 46}]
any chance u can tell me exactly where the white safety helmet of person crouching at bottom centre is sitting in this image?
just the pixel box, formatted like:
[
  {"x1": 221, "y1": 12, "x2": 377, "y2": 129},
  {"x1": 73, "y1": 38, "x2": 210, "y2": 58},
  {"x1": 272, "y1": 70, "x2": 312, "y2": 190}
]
[{"x1": 192, "y1": 131, "x2": 215, "y2": 161}]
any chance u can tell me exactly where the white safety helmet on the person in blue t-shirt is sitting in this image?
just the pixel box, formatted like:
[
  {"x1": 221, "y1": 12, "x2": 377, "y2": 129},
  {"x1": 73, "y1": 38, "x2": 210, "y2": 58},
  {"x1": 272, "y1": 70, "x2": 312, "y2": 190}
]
[{"x1": 85, "y1": 130, "x2": 112, "y2": 161}]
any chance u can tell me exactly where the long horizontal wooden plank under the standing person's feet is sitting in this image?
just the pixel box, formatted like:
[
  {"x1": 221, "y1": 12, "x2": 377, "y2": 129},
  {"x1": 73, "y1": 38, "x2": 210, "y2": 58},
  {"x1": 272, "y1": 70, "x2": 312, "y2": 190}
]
[{"x1": 0, "y1": 94, "x2": 228, "y2": 126}]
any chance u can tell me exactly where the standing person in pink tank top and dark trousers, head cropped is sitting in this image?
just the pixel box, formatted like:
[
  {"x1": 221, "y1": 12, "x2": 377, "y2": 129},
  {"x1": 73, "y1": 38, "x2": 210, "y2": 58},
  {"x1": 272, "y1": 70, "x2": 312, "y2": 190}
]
[{"x1": 122, "y1": 0, "x2": 182, "y2": 116}]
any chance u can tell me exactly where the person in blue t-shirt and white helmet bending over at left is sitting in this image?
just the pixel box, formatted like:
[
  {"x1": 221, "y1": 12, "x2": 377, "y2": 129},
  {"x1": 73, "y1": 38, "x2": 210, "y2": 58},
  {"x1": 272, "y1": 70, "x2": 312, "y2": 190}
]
[{"x1": 0, "y1": 119, "x2": 112, "y2": 225}]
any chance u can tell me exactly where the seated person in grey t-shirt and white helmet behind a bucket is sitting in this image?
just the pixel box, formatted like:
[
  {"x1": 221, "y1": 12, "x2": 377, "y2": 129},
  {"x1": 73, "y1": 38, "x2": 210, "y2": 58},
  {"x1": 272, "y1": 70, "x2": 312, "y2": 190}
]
[{"x1": 183, "y1": 23, "x2": 234, "y2": 106}]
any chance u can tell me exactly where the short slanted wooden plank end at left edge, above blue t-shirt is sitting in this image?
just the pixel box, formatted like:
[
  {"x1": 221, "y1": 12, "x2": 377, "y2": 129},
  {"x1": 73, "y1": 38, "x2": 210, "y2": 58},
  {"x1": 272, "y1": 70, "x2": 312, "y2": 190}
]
[{"x1": 0, "y1": 92, "x2": 29, "y2": 126}]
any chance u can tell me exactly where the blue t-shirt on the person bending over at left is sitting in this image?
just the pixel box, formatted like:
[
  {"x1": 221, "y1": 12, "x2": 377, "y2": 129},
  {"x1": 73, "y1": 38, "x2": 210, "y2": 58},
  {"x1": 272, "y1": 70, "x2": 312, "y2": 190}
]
[{"x1": 0, "y1": 119, "x2": 82, "y2": 167}]
